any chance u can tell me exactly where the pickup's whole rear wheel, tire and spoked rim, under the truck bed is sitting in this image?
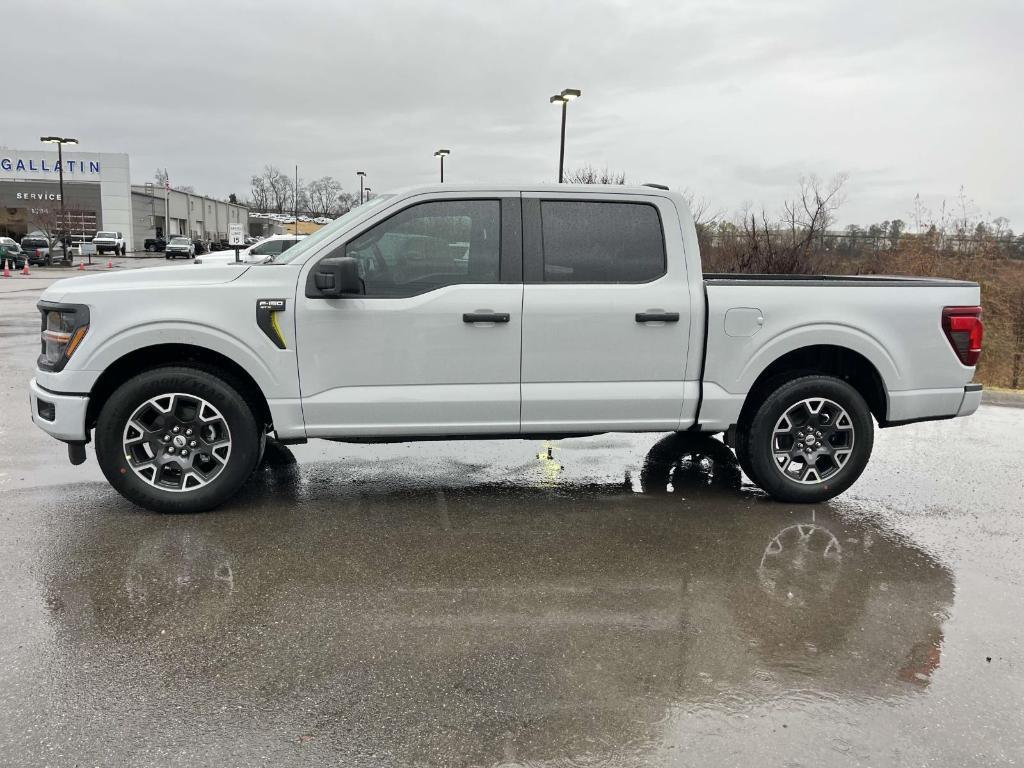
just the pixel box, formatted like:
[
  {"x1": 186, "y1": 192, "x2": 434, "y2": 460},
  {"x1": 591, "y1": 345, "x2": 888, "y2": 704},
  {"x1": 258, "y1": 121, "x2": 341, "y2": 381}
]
[{"x1": 737, "y1": 376, "x2": 874, "y2": 503}]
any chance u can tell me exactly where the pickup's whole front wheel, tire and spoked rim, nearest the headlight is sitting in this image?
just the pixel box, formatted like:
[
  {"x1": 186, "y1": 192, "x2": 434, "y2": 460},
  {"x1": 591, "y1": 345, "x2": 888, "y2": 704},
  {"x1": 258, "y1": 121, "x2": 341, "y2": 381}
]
[{"x1": 95, "y1": 367, "x2": 261, "y2": 512}]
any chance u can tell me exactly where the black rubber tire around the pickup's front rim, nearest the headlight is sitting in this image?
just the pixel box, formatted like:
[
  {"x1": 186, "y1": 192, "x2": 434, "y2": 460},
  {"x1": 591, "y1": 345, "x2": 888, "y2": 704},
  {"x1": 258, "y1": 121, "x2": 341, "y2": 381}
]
[{"x1": 95, "y1": 367, "x2": 262, "y2": 513}]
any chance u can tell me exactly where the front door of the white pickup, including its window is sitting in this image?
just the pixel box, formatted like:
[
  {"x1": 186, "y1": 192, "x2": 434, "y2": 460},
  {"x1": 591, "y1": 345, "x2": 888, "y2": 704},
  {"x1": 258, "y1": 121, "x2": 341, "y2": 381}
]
[{"x1": 296, "y1": 196, "x2": 522, "y2": 437}]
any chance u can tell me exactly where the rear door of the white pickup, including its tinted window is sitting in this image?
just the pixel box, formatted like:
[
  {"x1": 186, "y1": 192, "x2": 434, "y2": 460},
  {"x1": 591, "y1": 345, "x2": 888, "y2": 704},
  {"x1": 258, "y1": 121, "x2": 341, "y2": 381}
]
[{"x1": 522, "y1": 194, "x2": 690, "y2": 432}]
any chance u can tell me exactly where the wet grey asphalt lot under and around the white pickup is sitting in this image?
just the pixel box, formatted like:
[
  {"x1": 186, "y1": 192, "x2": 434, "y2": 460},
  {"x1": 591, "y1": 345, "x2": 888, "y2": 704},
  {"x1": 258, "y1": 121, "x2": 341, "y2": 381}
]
[{"x1": 0, "y1": 268, "x2": 1024, "y2": 766}]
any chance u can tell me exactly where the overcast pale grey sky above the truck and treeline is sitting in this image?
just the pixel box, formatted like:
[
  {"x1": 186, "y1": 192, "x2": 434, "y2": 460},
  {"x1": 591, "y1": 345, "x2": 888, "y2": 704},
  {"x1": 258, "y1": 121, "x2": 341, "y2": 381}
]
[{"x1": 0, "y1": 0, "x2": 1024, "y2": 230}]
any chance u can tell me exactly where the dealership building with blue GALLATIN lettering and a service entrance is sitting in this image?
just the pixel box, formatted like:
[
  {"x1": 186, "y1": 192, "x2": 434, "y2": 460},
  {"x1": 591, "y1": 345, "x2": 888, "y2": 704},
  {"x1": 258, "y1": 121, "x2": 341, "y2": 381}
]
[{"x1": 0, "y1": 148, "x2": 249, "y2": 256}]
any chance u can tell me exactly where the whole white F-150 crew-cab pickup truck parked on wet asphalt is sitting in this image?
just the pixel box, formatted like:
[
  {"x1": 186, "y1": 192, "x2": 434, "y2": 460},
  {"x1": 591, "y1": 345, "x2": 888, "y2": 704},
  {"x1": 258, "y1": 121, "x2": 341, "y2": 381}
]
[{"x1": 31, "y1": 184, "x2": 982, "y2": 511}]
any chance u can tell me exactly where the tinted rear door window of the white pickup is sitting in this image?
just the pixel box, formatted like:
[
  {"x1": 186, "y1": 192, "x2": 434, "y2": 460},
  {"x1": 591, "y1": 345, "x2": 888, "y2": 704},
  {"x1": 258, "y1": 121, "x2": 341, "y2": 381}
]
[{"x1": 541, "y1": 200, "x2": 666, "y2": 283}]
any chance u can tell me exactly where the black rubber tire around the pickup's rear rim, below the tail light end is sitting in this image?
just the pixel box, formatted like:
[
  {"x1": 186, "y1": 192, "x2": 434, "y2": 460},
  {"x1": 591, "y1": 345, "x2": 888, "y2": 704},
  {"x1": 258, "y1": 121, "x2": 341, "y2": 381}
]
[{"x1": 736, "y1": 376, "x2": 874, "y2": 504}]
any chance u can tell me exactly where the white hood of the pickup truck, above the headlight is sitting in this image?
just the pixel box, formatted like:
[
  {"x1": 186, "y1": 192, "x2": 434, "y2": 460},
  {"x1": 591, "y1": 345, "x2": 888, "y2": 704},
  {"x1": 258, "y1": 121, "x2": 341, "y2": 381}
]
[{"x1": 41, "y1": 264, "x2": 248, "y2": 301}]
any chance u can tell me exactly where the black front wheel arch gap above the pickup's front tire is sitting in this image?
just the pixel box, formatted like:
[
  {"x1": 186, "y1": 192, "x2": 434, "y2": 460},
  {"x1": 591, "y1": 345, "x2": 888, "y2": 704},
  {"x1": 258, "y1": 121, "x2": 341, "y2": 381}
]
[{"x1": 85, "y1": 343, "x2": 273, "y2": 429}]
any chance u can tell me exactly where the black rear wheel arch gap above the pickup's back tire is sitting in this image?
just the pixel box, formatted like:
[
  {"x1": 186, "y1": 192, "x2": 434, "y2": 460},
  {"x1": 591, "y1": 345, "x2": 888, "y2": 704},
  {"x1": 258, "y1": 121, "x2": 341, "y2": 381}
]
[{"x1": 738, "y1": 344, "x2": 889, "y2": 425}]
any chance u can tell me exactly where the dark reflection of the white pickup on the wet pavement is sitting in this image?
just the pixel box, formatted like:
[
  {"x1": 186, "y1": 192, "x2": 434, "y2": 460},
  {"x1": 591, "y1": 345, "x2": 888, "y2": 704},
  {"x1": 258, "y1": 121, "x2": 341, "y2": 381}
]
[{"x1": 19, "y1": 438, "x2": 970, "y2": 765}]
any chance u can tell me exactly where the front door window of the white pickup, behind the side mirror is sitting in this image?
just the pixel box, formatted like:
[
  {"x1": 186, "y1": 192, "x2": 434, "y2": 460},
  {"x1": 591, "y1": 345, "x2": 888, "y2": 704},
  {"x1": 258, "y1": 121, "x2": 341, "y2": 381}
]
[{"x1": 345, "y1": 200, "x2": 501, "y2": 298}]
